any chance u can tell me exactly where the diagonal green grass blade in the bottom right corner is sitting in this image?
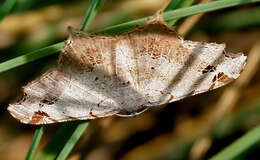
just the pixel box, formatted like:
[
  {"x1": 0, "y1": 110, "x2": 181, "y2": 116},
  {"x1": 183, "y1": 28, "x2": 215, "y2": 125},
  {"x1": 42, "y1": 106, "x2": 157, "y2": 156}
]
[{"x1": 210, "y1": 126, "x2": 260, "y2": 160}]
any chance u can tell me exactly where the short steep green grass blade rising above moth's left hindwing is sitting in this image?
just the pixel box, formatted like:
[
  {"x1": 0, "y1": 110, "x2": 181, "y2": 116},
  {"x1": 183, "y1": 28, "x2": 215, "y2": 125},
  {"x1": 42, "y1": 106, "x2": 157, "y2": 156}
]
[{"x1": 81, "y1": 0, "x2": 105, "y2": 32}]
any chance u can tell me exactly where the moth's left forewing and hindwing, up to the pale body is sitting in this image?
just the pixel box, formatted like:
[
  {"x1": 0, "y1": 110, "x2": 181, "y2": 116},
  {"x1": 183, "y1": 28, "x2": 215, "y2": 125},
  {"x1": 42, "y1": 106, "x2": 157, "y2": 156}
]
[{"x1": 8, "y1": 30, "x2": 120, "y2": 124}]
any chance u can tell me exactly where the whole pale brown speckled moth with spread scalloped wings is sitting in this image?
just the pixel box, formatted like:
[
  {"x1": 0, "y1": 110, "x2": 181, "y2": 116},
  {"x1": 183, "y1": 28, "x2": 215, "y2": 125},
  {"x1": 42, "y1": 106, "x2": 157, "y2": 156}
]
[{"x1": 8, "y1": 18, "x2": 246, "y2": 124}]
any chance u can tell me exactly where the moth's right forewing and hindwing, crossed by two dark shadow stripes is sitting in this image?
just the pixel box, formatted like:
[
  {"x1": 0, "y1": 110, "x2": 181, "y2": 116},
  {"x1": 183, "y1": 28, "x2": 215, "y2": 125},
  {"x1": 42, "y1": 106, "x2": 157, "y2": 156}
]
[{"x1": 126, "y1": 24, "x2": 246, "y2": 106}]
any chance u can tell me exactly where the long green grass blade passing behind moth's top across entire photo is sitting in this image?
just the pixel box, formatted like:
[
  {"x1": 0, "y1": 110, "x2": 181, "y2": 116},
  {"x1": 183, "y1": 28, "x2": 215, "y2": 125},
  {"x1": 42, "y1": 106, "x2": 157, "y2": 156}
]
[{"x1": 0, "y1": 0, "x2": 260, "y2": 73}]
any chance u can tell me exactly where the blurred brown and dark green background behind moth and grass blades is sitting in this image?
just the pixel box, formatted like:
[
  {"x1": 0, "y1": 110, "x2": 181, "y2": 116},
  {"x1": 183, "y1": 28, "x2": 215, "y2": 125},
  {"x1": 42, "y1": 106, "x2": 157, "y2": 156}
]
[{"x1": 0, "y1": 0, "x2": 260, "y2": 160}]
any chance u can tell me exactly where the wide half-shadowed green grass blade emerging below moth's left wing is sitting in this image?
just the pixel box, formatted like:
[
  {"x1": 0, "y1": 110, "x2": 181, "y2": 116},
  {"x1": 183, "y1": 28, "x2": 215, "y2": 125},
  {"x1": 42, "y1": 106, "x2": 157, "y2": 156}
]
[{"x1": 36, "y1": 121, "x2": 89, "y2": 160}]
